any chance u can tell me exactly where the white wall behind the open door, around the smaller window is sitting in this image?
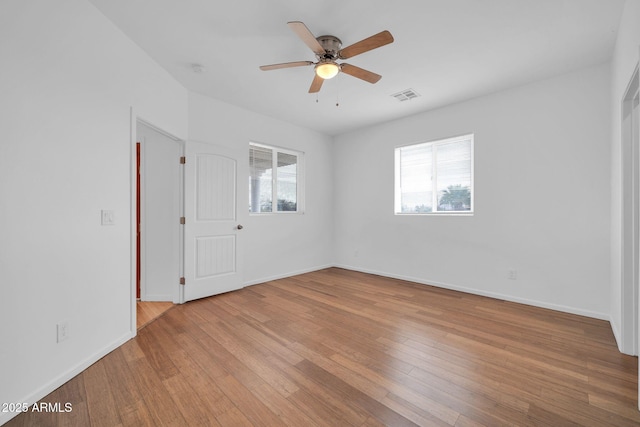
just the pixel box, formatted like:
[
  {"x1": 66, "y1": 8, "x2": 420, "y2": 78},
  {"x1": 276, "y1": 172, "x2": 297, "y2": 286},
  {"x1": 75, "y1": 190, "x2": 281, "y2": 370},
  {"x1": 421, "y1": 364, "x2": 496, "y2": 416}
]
[{"x1": 189, "y1": 93, "x2": 333, "y2": 284}]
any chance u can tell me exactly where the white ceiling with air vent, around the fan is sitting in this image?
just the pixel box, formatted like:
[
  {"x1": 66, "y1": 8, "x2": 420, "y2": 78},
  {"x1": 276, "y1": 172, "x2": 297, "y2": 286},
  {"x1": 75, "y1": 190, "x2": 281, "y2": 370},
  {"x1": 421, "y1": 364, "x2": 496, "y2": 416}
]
[{"x1": 89, "y1": 0, "x2": 624, "y2": 135}]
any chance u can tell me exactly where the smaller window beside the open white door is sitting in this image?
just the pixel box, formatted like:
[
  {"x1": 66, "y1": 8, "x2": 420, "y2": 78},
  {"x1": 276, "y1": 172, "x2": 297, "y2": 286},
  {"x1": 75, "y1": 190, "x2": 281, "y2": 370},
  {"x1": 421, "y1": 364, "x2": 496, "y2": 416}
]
[{"x1": 249, "y1": 143, "x2": 303, "y2": 213}]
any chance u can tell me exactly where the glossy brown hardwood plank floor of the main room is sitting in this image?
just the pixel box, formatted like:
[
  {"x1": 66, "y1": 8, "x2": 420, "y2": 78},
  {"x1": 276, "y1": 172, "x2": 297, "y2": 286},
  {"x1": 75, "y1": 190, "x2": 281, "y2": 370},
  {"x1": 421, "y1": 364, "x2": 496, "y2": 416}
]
[{"x1": 8, "y1": 268, "x2": 640, "y2": 427}]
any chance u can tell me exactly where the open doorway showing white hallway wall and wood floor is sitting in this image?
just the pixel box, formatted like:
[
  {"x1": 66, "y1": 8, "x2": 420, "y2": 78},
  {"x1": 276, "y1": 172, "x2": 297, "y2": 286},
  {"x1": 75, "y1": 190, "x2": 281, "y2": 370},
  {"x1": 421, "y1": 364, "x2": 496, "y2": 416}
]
[{"x1": 135, "y1": 119, "x2": 183, "y2": 329}]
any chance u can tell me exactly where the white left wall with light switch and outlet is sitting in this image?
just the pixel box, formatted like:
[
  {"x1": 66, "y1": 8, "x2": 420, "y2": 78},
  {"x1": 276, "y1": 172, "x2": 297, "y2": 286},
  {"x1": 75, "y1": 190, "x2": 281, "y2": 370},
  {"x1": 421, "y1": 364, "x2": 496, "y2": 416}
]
[{"x1": 0, "y1": 0, "x2": 188, "y2": 424}]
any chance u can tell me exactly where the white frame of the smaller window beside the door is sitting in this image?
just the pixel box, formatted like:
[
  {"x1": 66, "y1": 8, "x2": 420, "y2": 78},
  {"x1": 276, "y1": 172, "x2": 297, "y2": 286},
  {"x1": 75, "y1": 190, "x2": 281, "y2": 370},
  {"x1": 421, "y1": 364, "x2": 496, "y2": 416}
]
[{"x1": 248, "y1": 141, "x2": 305, "y2": 216}]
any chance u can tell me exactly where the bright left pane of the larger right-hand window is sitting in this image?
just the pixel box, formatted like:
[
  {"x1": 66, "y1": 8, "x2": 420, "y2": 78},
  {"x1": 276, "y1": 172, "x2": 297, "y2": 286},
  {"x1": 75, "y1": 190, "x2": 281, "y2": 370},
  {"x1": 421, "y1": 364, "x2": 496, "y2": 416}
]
[{"x1": 400, "y1": 144, "x2": 433, "y2": 213}]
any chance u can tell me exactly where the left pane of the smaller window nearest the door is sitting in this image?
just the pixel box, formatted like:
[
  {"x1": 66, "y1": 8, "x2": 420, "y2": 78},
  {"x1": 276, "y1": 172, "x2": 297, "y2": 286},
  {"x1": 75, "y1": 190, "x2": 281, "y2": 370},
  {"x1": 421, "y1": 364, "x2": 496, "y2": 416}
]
[{"x1": 249, "y1": 145, "x2": 273, "y2": 212}]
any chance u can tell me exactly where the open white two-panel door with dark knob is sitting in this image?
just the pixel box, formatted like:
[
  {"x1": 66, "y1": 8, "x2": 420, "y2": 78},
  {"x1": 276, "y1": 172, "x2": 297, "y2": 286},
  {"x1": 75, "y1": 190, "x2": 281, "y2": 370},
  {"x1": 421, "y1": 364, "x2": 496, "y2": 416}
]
[{"x1": 182, "y1": 141, "x2": 248, "y2": 302}]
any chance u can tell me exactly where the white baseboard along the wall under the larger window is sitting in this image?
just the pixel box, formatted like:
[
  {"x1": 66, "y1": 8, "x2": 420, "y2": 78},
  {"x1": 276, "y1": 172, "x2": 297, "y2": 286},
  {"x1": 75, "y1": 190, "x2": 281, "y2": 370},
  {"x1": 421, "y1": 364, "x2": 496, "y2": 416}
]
[{"x1": 335, "y1": 264, "x2": 611, "y2": 323}]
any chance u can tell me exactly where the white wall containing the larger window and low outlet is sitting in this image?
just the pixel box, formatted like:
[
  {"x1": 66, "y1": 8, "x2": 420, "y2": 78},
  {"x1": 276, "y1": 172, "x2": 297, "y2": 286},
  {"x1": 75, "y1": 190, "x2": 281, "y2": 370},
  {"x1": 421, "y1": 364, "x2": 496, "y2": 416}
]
[{"x1": 334, "y1": 65, "x2": 610, "y2": 319}]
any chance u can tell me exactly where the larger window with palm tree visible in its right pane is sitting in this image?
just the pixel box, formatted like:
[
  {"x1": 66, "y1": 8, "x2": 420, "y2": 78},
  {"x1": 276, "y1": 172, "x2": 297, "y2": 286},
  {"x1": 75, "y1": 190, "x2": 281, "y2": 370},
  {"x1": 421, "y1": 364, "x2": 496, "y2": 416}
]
[{"x1": 395, "y1": 134, "x2": 473, "y2": 214}]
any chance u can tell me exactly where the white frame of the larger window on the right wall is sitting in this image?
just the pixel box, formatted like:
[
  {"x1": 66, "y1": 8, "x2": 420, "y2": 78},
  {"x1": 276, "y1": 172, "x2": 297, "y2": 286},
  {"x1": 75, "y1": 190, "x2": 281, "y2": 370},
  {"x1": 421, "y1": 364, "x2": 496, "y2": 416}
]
[{"x1": 393, "y1": 133, "x2": 475, "y2": 216}]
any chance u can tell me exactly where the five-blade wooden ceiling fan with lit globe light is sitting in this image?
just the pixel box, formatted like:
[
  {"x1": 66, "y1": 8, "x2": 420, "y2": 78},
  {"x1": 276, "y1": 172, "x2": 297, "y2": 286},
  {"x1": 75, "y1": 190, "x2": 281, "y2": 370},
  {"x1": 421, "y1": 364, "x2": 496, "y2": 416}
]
[{"x1": 260, "y1": 21, "x2": 393, "y2": 93}]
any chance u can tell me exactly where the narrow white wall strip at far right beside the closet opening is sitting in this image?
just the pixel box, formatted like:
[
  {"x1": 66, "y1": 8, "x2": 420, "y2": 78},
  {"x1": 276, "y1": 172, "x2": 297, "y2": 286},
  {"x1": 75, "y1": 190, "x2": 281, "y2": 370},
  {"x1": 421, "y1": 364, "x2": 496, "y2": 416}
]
[{"x1": 609, "y1": 0, "x2": 640, "y2": 352}]
